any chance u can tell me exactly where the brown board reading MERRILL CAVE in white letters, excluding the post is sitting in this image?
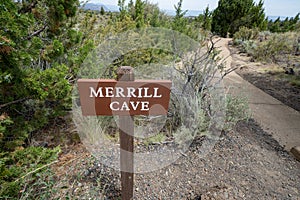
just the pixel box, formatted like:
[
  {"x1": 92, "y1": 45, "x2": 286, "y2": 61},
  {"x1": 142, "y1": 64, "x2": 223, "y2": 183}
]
[{"x1": 78, "y1": 79, "x2": 172, "y2": 116}]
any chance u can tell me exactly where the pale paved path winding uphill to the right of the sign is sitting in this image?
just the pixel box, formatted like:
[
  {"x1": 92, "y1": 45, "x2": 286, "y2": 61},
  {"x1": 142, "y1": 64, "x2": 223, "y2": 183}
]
[{"x1": 216, "y1": 38, "x2": 300, "y2": 151}]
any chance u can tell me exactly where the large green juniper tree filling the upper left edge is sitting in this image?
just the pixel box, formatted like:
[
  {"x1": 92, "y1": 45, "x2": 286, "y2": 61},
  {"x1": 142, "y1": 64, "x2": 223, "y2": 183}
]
[{"x1": 0, "y1": 0, "x2": 79, "y2": 151}]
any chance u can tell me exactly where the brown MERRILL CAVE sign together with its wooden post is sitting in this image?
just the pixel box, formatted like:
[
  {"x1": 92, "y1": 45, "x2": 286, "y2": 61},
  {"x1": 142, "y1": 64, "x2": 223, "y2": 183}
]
[{"x1": 78, "y1": 66, "x2": 172, "y2": 200}]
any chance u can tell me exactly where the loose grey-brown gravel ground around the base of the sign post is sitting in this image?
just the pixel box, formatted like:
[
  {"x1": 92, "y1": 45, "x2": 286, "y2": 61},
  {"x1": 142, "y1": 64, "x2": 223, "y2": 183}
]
[{"x1": 52, "y1": 120, "x2": 300, "y2": 200}]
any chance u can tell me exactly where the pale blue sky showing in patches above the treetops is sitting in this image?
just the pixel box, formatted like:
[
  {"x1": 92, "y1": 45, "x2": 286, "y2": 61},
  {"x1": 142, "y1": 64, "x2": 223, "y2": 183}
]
[{"x1": 90, "y1": 0, "x2": 300, "y2": 17}]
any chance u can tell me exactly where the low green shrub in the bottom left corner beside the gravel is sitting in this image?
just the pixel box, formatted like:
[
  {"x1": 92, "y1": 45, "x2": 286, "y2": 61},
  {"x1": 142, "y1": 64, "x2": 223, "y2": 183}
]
[{"x1": 0, "y1": 147, "x2": 60, "y2": 199}]
